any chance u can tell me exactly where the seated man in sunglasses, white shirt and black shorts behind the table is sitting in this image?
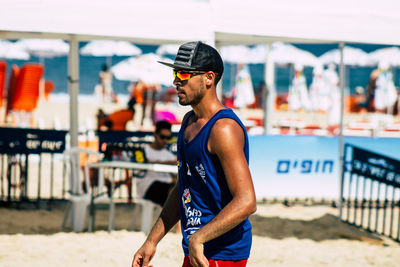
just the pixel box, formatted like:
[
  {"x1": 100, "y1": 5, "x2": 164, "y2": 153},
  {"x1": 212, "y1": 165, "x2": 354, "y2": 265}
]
[{"x1": 137, "y1": 121, "x2": 176, "y2": 206}]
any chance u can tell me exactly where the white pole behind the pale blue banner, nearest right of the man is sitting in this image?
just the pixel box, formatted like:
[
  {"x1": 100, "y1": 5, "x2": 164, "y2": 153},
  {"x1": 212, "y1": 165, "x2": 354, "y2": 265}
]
[{"x1": 263, "y1": 42, "x2": 276, "y2": 134}]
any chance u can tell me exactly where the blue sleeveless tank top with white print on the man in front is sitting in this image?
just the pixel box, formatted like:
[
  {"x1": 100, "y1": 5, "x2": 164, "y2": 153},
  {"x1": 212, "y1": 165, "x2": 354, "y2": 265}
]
[{"x1": 178, "y1": 109, "x2": 252, "y2": 260}]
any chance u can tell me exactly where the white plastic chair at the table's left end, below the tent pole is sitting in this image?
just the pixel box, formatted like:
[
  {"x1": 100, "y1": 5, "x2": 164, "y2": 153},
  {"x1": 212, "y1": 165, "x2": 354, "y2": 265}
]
[{"x1": 62, "y1": 147, "x2": 103, "y2": 232}]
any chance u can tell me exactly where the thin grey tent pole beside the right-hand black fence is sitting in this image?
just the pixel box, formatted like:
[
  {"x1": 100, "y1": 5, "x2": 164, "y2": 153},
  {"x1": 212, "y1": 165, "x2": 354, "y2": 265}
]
[{"x1": 339, "y1": 42, "x2": 344, "y2": 220}]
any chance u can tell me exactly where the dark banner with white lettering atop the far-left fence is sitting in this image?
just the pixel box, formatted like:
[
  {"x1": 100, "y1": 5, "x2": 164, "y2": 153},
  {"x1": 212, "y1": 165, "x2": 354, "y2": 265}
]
[{"x1": 0, "y1": 127, "x2": 68, "y2": 154}]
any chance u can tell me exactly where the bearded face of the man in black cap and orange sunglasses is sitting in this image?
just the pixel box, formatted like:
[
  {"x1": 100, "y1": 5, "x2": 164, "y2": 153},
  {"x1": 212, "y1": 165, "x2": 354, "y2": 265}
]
[{"x1": 174, "y1": 69, "x2": 205, "y2": 106}]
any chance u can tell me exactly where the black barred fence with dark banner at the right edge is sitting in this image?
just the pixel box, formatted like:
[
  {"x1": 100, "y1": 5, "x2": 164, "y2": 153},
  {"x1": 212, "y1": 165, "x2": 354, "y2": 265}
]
[{"x1": 340, "y1": 144, "x2": 400, "y2": 242}]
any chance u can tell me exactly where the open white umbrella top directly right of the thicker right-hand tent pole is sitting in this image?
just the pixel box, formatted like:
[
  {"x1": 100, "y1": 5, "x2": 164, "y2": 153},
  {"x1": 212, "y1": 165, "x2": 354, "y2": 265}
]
[{"x1": 271, "y1": 42, "x2": 318, "y2": 66}]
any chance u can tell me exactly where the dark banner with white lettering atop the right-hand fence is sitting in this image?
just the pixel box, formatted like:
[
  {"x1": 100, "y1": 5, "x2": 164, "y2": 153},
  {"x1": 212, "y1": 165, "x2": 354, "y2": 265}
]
[{"x1": 346, "y1": 145, "x2": 400, "y2": 187}]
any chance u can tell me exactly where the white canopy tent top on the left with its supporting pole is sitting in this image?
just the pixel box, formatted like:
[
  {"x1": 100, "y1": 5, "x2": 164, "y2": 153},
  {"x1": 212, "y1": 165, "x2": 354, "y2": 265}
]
[{"x1": 0, "y1": 0, "x2": 214, "y2": 150}]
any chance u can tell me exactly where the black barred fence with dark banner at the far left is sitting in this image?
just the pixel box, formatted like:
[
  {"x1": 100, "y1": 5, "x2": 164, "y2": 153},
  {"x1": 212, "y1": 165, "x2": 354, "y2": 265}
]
[{"x1": 0, "y1": 128, "x2": 67, "y2": 203}]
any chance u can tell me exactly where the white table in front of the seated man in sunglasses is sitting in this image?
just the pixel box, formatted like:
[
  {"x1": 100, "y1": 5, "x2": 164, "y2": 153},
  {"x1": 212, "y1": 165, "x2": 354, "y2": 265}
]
[{"x1": 88, "y1": 161, "x2": 178, "y2": 232}]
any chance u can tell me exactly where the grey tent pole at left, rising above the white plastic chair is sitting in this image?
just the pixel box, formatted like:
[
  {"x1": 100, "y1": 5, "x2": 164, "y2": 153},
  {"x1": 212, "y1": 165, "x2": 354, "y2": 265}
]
[{"x1": 68, "y1": 35, "x2": 79, "y2": 147}]
